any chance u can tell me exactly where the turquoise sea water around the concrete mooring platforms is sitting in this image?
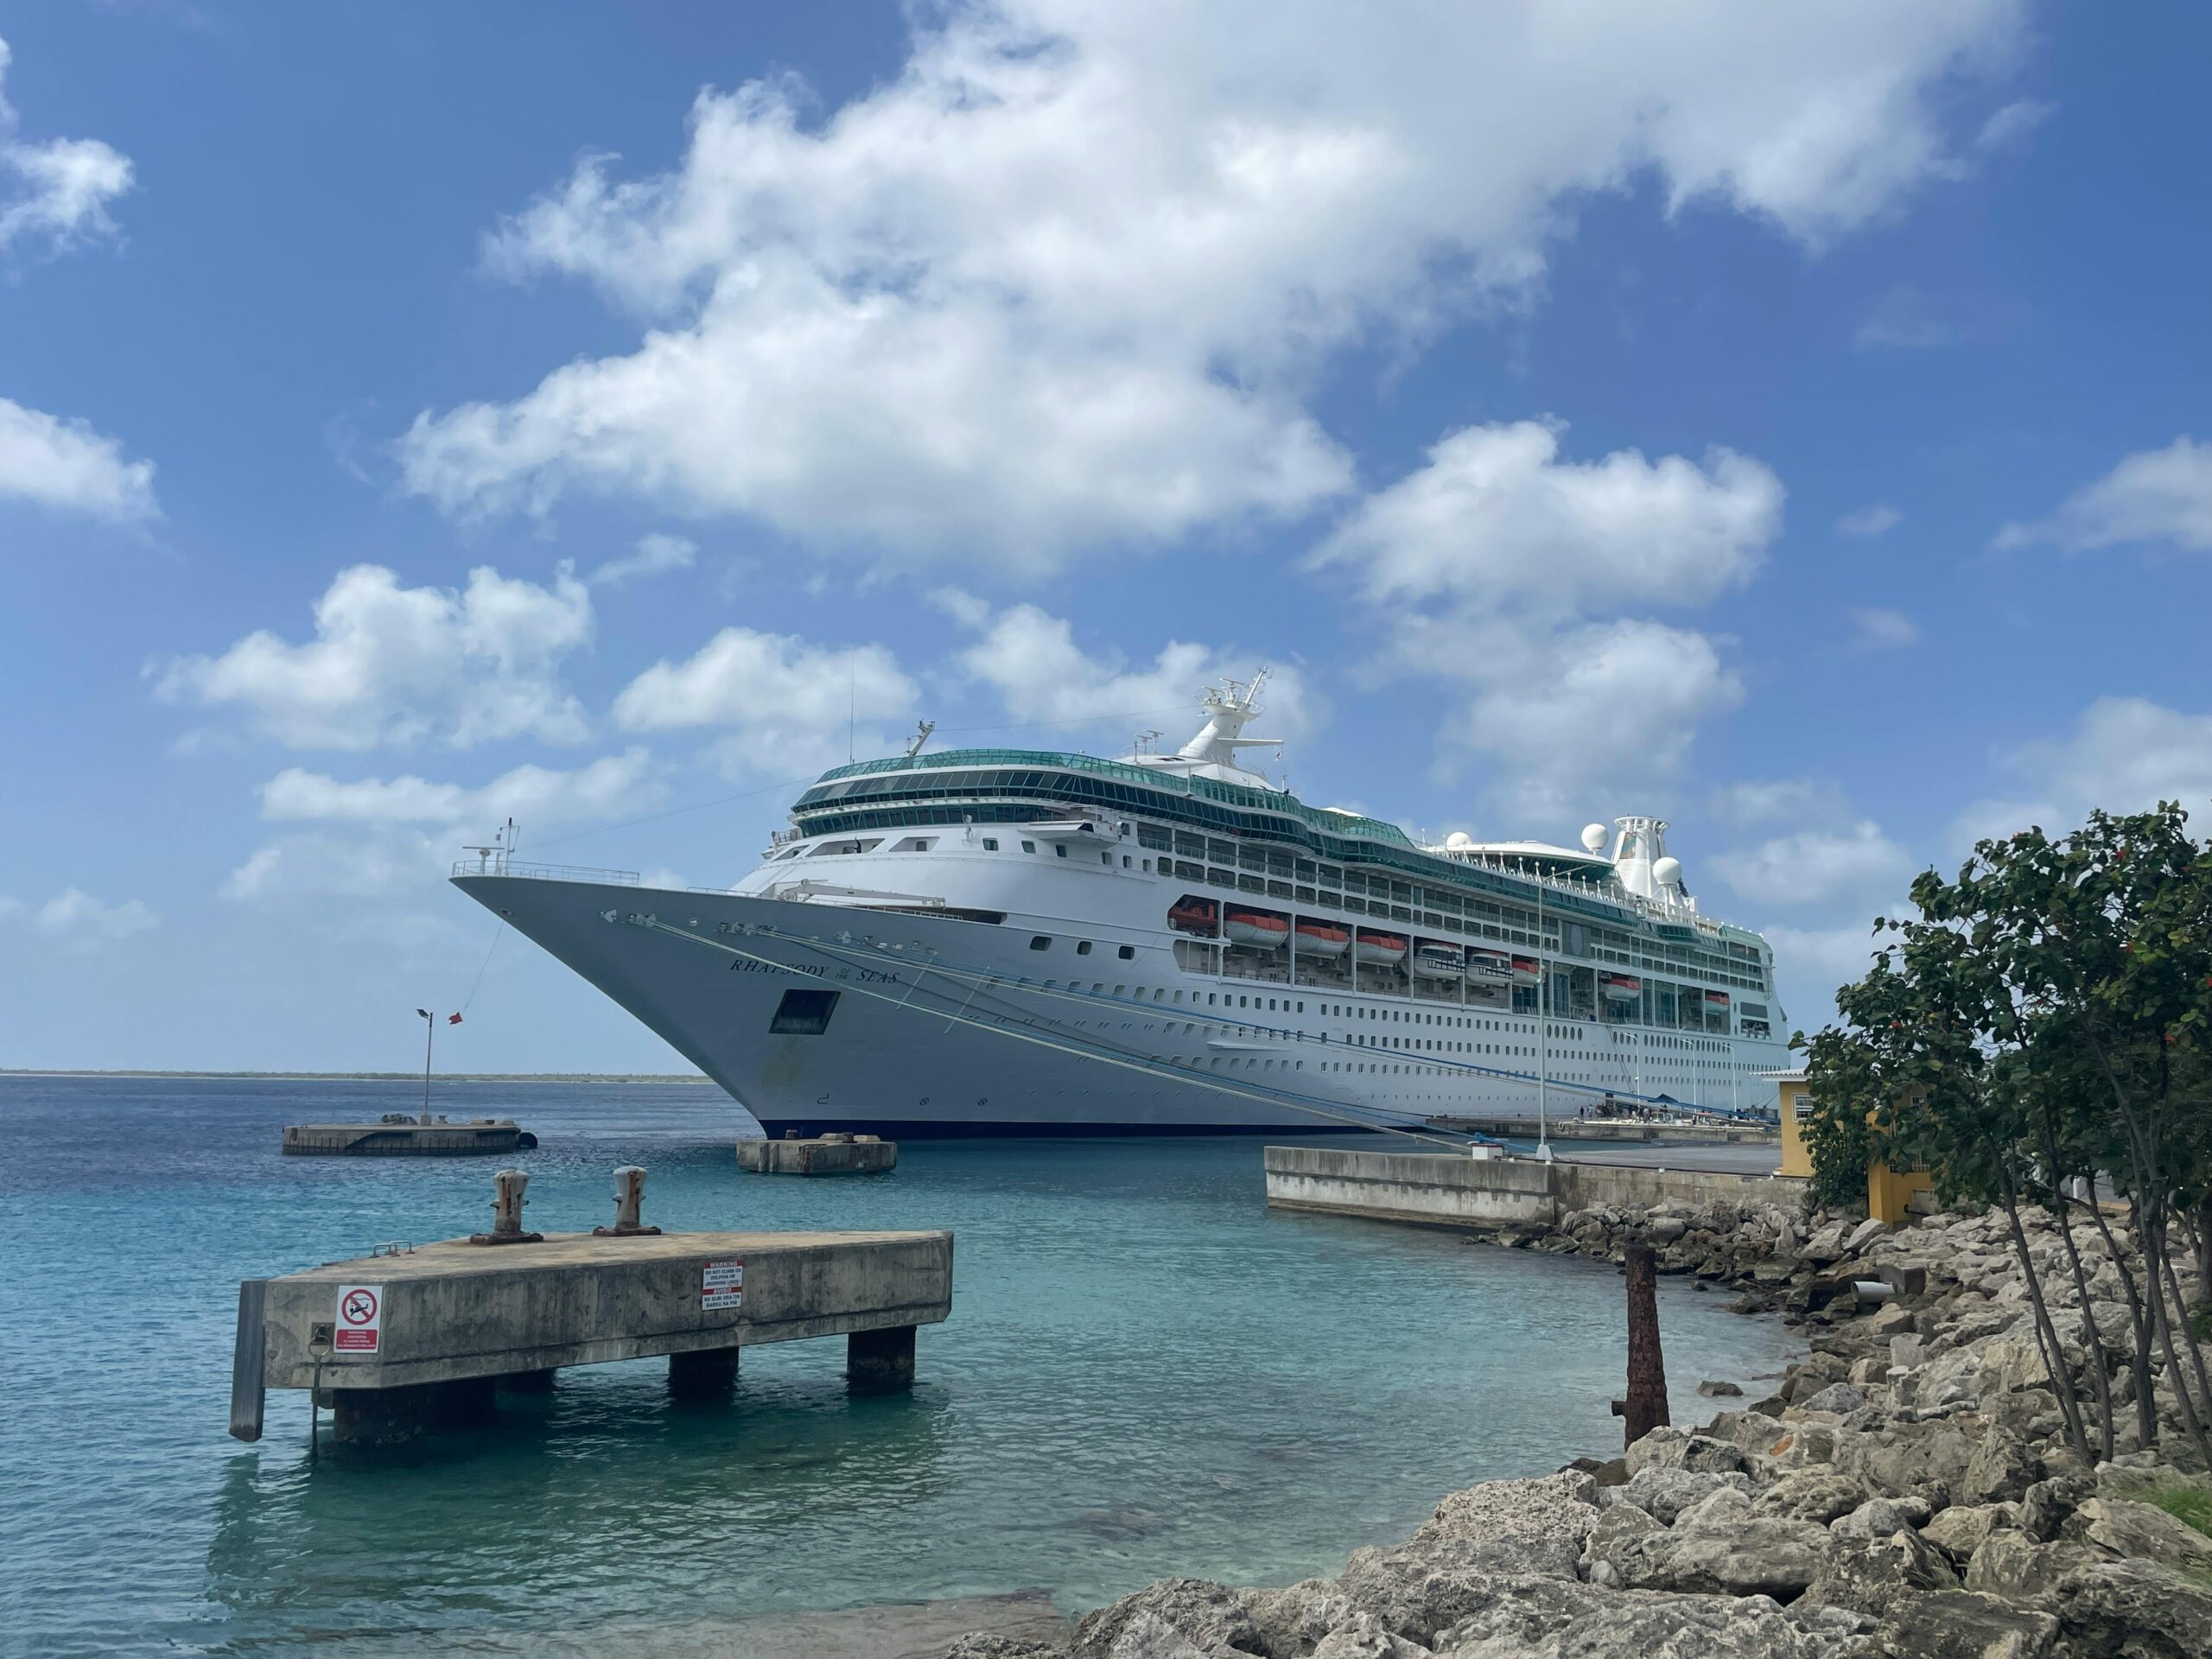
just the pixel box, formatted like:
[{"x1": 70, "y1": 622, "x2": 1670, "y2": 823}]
[{"x1": 0, "y1": 1079, "x2": 1792, "y2": 1652}]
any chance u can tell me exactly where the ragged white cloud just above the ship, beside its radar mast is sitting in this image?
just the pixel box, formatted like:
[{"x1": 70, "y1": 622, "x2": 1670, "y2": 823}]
[{"x1": 938, "y1": 593, "x2": 1316, "y2": 750}]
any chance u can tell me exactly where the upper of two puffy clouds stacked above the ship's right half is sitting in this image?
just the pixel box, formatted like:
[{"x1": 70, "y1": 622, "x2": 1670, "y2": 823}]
[{"x1": 1316, "y1": 420, "x2": 1783, "y2": 611}]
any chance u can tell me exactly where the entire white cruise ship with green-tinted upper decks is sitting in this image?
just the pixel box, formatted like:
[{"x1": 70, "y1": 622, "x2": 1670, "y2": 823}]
[{"x1": 454, "y1": 671, "x2": 1787, "y2": 1139}]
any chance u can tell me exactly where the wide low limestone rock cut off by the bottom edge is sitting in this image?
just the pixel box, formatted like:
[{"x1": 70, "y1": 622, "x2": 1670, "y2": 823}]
[{"x1": 1440, "y1": 1595, "x2": 1878, "y2": 1659}]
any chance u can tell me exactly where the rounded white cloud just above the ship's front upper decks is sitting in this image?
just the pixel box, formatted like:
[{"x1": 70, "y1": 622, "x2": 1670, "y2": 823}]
[{"x1": 615, "y1": 628, "x2": 916, "y2": 772}]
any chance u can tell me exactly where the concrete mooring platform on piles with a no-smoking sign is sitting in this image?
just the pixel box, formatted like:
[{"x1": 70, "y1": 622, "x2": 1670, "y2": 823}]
[{"x1": 230, "y1": 1232, "x2": 953, "y2": 1442}]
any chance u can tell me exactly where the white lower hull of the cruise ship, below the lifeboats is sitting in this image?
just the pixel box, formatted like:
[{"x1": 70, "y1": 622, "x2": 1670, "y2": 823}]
[{"x1": 455, "y1": 871, "x2": 1787, "y2": 1139}]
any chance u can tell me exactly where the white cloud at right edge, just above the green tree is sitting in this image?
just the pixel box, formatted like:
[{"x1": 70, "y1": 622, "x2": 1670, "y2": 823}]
[{"x1": 1953, "y1": 696, "x2": 2212, "y2": 847}]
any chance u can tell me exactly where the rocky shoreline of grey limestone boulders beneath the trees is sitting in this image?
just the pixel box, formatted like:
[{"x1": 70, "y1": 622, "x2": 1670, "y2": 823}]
[{"x1": 944, "y1": 1204, "x2": 2212, "y2": 1659}]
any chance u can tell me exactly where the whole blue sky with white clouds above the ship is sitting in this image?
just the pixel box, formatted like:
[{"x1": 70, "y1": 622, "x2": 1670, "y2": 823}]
[{"x1": 0, "y1": 0, "x2": 2212, "y2": 1071}]
